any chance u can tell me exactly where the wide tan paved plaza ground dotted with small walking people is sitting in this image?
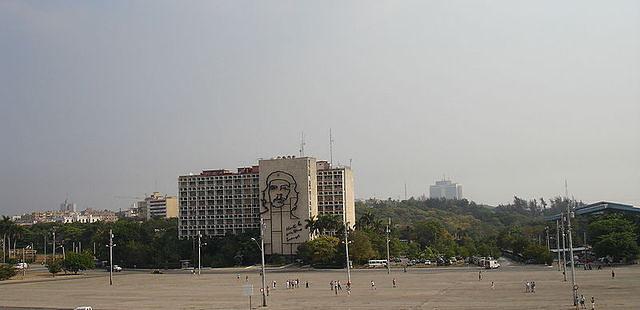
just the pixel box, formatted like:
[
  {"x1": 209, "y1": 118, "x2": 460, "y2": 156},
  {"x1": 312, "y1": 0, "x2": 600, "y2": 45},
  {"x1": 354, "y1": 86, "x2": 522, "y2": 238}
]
[{"x1": 0, "y1": 266, "x2": 640, "y2": 310}]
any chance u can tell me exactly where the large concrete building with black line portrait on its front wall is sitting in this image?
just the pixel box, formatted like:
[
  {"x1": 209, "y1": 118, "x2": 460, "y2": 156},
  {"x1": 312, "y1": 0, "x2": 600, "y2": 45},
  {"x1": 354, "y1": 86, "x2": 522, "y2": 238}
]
[{"x1": 178, "y1": 156, "x2": 355, "y2": 255}]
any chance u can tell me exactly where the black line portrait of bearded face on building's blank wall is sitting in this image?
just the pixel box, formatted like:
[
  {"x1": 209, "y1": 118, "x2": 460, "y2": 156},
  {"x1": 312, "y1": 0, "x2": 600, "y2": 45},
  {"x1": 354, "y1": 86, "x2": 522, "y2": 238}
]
[{"x1": 262, "y1": 171, "x2": 299, "y2": 219}]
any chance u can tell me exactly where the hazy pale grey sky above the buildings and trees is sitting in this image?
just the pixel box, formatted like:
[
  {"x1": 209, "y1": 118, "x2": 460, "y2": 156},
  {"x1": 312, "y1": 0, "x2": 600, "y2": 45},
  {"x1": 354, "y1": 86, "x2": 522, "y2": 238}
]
[{"x1": 0, "y1": 0, "x2": 640, "y2": 214}]
